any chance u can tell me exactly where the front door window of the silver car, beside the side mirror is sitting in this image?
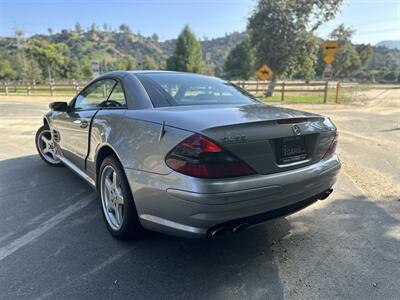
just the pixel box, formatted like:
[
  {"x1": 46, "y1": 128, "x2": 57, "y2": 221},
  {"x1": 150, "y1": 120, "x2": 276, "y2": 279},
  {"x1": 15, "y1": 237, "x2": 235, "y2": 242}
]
[{"x1": 74, "y1": 79, "x2": 116, "y2": 110}]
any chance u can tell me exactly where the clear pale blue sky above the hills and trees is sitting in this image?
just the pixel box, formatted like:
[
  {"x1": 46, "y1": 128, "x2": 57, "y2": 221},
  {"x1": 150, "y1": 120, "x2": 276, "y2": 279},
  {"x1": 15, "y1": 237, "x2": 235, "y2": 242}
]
[{"x1": 0, "y1": 0, "x2": 400, "y2": 44}]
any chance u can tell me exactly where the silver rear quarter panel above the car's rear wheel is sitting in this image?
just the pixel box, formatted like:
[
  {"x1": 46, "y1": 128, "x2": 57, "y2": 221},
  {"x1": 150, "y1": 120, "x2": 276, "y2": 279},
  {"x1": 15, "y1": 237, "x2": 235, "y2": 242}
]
[{"x1": 87, "y1": 110, "x2": 193, "y2": 178}]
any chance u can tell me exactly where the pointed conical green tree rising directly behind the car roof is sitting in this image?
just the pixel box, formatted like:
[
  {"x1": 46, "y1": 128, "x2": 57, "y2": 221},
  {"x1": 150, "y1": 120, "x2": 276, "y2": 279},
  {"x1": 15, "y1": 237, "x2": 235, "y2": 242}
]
[{"x1": 167, "y1": 25, "x2": 204, "y2": 73}]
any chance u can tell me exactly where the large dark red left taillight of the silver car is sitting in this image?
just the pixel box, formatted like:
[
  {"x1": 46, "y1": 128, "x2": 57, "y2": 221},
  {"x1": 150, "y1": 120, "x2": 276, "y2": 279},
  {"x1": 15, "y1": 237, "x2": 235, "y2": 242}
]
[{"x1": 165, "y1": 134, "x2": 256, "y2": 178}]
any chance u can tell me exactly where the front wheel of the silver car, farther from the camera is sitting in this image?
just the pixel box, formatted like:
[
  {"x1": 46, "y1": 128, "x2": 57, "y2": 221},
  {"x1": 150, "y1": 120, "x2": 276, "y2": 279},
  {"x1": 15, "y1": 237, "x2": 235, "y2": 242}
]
[{"x1": 35, "y1": 124, "x2": 63, "y2": 167}]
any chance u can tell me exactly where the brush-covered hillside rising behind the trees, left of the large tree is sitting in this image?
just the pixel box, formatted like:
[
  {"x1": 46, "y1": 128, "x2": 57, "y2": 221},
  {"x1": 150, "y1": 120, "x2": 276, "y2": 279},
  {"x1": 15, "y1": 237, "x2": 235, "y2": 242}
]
[{"x1": 0, "y1": 29, "x2": 246, "y2": 75}]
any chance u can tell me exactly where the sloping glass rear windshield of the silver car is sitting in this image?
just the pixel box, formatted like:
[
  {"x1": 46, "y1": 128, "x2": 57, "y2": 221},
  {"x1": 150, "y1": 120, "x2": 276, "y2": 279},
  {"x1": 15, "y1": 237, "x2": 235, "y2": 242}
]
[{"x1": 136, "y1": 72, "x2": 258, "y2": 107}]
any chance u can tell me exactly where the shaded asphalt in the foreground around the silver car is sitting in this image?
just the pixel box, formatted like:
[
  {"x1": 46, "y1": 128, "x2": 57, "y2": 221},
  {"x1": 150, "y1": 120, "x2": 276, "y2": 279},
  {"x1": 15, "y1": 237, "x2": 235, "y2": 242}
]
[{"x1": 0, "y1": 155, "x2": 400, "y2": 299}]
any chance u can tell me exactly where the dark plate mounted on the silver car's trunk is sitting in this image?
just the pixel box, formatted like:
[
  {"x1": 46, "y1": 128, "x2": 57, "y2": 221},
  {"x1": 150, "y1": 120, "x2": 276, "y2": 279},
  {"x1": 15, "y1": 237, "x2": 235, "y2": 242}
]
[{"x1": 275, "y1": 136, "x2": 307, "y2": 165}]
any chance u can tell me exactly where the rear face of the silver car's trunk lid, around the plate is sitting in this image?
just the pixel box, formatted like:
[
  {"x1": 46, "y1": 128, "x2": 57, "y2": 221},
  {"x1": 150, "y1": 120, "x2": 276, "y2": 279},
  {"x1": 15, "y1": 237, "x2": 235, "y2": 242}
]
[{"x1": 201, "y1": 116, "x2": 336, "y2": 174}]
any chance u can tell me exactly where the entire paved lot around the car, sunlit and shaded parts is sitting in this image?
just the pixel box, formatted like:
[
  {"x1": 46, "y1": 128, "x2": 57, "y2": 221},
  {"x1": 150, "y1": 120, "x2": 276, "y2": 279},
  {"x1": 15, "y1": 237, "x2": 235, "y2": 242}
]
[{"x1": 0, "y1": 98, "x2": 400, "y2": 299}]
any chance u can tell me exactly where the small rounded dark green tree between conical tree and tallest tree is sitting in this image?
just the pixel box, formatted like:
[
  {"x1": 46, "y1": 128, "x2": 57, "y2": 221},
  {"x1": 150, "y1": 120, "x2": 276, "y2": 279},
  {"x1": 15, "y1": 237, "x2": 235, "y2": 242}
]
[{"x1": 224, "y1": 39, "x2": 255, "y2": 80}]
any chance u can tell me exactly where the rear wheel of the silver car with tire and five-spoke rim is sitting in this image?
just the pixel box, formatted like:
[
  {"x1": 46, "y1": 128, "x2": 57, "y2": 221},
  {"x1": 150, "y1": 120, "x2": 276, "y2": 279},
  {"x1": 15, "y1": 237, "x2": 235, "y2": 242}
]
[{"x1": 98, "y1": 155, "x2": 144, "y2": 239}]
